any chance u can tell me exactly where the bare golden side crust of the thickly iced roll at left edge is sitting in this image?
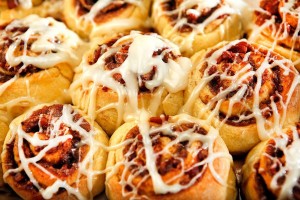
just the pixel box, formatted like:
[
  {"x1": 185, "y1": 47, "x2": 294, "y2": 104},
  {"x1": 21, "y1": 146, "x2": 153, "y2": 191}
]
[{"x1": 0, "y1": 64, "x2": 73, "y2": 116}]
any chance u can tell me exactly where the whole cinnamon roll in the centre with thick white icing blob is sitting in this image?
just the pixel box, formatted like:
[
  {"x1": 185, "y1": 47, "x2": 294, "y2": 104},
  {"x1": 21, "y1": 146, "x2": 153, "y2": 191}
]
[{"x1": 70, "y1": 31, "x2": 191, "y2": 134}]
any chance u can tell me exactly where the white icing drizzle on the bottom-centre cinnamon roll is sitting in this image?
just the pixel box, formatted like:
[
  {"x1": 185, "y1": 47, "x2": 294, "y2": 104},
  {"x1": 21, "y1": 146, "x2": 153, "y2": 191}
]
[{"x1": 108, "y1": 110, "x2": 232, "y2": 199}]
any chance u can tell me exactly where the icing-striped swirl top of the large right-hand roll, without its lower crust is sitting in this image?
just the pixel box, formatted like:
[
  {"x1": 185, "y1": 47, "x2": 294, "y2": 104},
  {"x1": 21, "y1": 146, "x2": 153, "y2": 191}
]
[{"x1": 182, "y1": 40, "x2": 299, "y2": 140}]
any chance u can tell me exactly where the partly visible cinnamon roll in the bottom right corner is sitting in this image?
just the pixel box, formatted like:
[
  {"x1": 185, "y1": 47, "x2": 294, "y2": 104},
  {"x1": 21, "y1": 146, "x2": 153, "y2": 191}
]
[{"x1": 242, "y1": 123, "x2": 300, "y2": 200}]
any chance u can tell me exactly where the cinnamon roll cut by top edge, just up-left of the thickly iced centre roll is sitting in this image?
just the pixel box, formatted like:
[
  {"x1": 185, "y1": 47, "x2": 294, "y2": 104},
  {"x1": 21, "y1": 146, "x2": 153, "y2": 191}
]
[{"x1": 64, "y1": 0, "x2": 151, "y2": 38}]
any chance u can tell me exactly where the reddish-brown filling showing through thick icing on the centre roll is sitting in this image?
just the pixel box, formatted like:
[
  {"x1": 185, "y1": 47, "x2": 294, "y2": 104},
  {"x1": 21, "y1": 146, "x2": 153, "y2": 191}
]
[{"x1": 89, "y1": 35, "x2": 178, "y2": 92}]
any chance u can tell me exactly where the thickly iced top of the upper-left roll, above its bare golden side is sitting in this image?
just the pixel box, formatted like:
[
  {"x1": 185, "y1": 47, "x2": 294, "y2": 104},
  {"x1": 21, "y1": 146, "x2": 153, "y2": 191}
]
[{"x1": 0, "y1": 15, "x2": 85, "y2": 111}]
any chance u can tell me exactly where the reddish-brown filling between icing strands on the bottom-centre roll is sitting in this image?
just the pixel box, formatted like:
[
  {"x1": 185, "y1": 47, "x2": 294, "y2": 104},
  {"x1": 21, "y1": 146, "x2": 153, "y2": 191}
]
[{"x1": 121, "y1": 117, "x2": 208, "y2": 195}]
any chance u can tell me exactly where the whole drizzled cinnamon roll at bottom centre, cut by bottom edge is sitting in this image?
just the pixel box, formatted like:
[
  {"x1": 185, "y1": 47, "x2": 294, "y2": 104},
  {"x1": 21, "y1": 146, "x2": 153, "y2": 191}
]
[{"x1": 106, "y1": 113, "x2": 236, "y2": 200}]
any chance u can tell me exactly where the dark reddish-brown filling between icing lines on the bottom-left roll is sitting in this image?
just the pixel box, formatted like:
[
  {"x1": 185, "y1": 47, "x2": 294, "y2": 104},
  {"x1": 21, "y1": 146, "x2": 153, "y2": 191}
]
[{"x1": 4, "y1": 104, "x2": 91, "y2": 192}]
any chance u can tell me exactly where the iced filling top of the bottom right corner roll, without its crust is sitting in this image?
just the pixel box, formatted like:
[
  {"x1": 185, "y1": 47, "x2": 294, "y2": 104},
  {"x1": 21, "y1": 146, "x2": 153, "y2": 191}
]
[{"x1": 258, "y1": 125, "x2": 300, "y2": 199}]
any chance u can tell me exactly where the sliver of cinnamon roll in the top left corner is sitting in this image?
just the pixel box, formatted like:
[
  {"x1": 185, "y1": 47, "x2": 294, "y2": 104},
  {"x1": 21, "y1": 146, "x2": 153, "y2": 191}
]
[{"x1": 0, "y1": 0, "x2": 63, "y2": 24}]
